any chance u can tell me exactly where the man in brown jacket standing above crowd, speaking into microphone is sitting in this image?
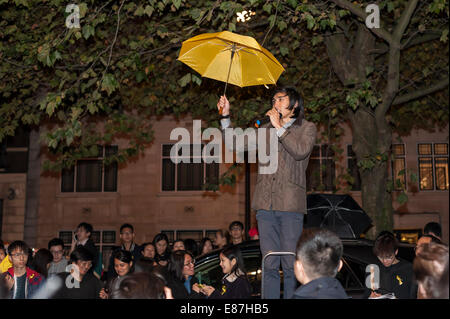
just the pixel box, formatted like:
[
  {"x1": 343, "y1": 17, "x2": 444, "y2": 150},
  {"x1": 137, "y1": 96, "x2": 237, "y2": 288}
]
[{"x1": 217, "y1": 87, "x2": 317, "y2": 299}]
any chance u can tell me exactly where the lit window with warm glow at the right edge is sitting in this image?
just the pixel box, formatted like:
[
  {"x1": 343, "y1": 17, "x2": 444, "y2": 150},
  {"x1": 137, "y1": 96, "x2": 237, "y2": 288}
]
[{"x1": 417, "y1": 143, "x2": 448, "y2": 190}]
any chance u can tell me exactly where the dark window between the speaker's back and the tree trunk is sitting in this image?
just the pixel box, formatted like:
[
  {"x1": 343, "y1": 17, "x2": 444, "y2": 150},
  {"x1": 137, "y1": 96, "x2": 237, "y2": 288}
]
[{"x1": 306, "y1": 144, "x2": 336, "y2": 191}]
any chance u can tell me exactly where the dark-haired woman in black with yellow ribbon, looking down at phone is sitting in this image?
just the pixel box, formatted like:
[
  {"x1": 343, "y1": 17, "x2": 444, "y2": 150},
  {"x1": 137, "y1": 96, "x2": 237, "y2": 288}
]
[{"x1": 201, "y1": 246, "x2": 252, "y2": 299}]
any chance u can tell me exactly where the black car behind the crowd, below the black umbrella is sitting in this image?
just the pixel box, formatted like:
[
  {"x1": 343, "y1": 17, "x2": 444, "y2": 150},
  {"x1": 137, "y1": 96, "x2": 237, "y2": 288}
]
[{"x1": 195, "y1": 239, "x2": 414, "y2": 298}]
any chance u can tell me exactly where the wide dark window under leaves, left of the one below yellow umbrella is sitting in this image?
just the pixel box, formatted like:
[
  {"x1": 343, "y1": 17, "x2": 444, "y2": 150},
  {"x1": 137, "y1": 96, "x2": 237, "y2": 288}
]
[{"x1": 61, "y1": 145, "x2": 118, "y2": 192}]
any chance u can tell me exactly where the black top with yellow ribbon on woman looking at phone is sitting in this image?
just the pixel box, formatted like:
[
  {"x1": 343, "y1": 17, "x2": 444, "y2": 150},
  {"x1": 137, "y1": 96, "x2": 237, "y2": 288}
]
[{"x1": 209, "y1": 275, "x2": 252, "y2": 299}]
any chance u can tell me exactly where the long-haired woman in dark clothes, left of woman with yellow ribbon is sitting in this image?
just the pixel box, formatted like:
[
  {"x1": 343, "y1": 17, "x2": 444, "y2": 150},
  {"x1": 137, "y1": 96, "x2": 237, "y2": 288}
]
[{"x1": 165, "y1": 250, "x2": 204, "y2": 299}]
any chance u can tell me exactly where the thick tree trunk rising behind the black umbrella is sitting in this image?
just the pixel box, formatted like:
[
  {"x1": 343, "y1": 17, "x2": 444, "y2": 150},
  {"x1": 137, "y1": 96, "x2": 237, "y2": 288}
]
[{"x1": 325, "y1": 23, "x2": 395, "y2": 238}]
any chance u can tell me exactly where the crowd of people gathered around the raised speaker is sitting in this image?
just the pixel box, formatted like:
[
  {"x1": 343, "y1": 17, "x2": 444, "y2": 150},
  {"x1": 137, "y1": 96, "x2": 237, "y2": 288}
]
[{"x1": 0, "y1": 221, "x2": 449, "y2": 299}]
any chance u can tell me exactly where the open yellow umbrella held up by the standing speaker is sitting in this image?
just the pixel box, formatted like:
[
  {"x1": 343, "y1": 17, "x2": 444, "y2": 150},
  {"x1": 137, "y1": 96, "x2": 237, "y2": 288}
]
[{"x1": 178, "y1": 31, "x2": 284, "y2": 95}]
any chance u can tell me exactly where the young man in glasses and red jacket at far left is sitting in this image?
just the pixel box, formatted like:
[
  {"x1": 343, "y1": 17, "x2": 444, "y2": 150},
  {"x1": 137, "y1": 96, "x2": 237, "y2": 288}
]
[{"x1": 5, "y1": 240, "x2": 44, "y2": 299}]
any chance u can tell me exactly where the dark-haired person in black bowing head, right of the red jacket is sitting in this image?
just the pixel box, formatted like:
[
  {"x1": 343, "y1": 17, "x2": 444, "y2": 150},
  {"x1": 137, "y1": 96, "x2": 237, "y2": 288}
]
[{"x1": 52, "y1": 246, "x2": 102, "y2": 299}]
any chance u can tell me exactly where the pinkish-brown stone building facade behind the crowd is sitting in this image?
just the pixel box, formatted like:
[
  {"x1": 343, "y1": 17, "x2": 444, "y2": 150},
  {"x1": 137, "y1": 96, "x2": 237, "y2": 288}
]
[{"x1": 0, "y1": 116, "x2": 449, "y2": 264}]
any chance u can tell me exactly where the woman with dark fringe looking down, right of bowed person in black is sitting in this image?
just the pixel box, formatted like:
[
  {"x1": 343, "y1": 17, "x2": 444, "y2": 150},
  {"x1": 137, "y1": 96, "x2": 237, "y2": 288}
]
[{"x1": 99, "y1": 249, "x2": 133, "y2": 299}]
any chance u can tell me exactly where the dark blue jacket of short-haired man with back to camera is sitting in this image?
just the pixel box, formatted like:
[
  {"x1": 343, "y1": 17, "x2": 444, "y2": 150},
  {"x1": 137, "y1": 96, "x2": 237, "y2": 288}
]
[{"x1": 292, "y1": 277, "x2": 349, "y2": 299}]
